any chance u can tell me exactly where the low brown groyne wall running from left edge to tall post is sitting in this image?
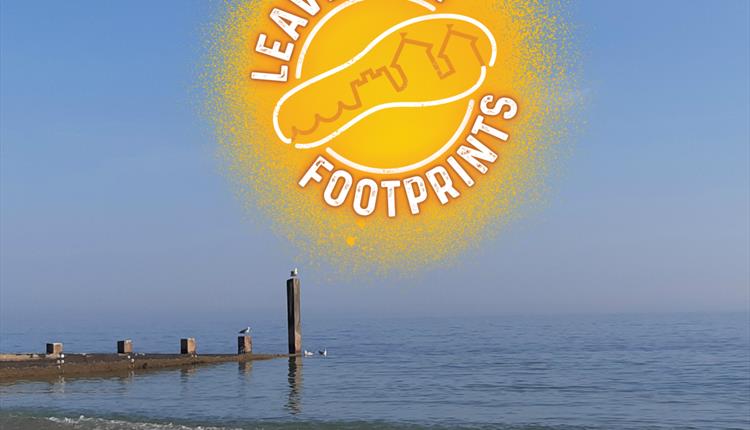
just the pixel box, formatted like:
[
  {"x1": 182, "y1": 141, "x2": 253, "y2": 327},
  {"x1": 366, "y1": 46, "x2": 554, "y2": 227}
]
[{"x1": 0, "y1": 353, "x2": 295, "y2": 383}]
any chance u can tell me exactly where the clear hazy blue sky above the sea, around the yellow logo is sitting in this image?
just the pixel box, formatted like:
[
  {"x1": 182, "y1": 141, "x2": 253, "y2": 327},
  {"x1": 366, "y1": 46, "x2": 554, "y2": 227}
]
[{"x1": 0, "y1": 0, "x2": 750, "y2": 322}]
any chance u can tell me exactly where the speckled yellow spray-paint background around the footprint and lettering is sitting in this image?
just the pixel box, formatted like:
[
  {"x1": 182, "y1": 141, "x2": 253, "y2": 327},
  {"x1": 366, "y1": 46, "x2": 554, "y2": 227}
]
[{"x1": 205, "y1": 0, "x2": 578, "y2": 275}]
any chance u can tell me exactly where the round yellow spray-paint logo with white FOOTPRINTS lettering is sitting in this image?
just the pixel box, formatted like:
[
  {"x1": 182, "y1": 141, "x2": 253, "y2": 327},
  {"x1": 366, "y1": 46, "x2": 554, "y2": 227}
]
[{"x1": 209, "y1": 0, "x2": 566, "y2": 271}]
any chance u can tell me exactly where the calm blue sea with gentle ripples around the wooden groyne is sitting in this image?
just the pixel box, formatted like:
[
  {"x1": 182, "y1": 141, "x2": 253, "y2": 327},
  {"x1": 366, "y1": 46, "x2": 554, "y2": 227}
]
[{"x1": 0, "y1": 313, "x2": 750, "y2": 430}]
